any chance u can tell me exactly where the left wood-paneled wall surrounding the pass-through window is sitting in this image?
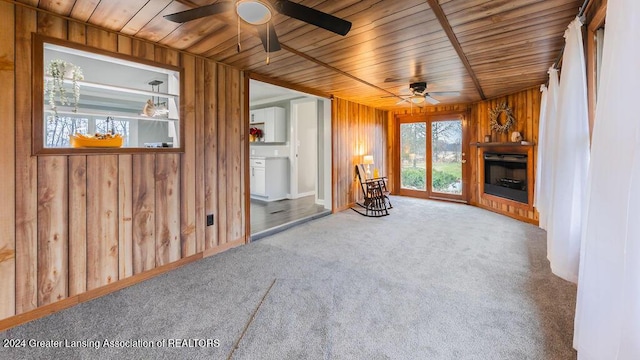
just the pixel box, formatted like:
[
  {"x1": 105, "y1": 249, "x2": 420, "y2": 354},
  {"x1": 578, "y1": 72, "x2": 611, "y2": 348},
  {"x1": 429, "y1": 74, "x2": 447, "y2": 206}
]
[{"x1": 0, "y1": 2, "x2": 247, "y2": 329}]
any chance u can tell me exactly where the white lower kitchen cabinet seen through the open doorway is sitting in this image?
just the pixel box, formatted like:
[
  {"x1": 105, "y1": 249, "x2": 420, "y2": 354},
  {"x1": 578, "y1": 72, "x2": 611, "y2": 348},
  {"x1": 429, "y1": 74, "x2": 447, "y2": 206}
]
[{"x1": 249, "y1": 157, "x2": 289, "y2": 201}]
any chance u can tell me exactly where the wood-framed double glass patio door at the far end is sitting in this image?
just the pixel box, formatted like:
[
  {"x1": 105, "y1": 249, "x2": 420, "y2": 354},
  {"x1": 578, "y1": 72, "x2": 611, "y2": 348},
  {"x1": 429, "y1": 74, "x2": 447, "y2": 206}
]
[{"x1": 397, "y1": 114, "x2": 468, "y2": 202}]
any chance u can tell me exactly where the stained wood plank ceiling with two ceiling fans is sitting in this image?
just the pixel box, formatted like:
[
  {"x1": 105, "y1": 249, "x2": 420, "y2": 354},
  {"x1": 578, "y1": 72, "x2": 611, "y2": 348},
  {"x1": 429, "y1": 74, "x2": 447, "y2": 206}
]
[{"x1": 17, "y1": 0, "x2": 583, "y2": 109}]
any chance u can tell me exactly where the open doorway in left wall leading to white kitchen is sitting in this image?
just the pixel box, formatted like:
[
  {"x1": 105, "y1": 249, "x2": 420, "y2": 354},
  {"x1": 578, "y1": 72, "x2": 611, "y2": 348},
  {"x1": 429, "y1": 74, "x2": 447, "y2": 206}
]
[{"x1": 247, "y1": 79, "x2": 332, "y2": 241}]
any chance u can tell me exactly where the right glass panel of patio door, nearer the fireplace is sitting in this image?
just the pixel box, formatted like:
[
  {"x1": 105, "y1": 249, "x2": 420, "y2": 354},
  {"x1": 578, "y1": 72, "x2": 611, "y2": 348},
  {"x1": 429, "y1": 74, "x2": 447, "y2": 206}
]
[{"x1": 431, "y1": 120, "x2": 464, "y2": 196}]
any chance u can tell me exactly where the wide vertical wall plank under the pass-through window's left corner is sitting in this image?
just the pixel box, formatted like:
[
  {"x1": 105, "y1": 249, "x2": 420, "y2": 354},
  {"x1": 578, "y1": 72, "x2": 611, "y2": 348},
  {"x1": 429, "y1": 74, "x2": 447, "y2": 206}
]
[{"x1": 38, "y1": 156, "x2": 68, "y2": 306}]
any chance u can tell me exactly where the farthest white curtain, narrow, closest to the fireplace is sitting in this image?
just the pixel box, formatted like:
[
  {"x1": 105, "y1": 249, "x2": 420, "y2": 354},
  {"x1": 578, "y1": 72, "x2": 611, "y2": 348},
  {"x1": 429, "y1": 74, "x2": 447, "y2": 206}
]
[{"x1": 534, "y1": 66, "x2": 559, "y2": 231}]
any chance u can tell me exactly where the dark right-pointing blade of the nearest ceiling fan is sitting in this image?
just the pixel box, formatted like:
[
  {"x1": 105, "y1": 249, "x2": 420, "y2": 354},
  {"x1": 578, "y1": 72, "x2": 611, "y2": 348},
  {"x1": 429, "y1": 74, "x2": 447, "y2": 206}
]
[{"x1": 274, "y1": 0, "x2": 351, "y2": 36}]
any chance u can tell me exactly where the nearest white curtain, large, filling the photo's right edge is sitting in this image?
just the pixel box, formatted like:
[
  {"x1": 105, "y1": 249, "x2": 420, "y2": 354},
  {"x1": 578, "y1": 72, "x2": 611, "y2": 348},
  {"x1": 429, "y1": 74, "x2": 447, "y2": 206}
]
[{"x1": 574, "y1": 0, "x2": 640, "y2": 360}]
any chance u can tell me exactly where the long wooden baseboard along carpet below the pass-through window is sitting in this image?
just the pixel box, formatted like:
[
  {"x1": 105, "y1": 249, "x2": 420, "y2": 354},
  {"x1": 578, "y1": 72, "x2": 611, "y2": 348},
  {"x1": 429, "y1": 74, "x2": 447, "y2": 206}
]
[{"x1": 0, "y1": 253, "x2": 203, "y2": 331}]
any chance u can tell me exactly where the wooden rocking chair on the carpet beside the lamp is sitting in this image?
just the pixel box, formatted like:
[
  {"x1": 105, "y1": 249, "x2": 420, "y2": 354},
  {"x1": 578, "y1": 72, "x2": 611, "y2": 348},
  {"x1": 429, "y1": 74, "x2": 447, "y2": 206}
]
[{"x1": 351, "y1": 164, "x2": 393, "y2": 217}]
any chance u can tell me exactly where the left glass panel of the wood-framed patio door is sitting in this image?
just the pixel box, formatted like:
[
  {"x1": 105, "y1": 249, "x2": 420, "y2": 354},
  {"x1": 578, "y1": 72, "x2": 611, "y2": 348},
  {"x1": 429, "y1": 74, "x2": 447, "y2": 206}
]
[{"x1": 400, "y1": 122, "x2": 427, "y2": 191}]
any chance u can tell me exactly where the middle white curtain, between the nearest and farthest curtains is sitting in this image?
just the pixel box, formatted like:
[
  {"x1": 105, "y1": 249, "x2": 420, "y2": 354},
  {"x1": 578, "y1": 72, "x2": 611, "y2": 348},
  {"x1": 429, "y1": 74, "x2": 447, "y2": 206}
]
[{"x1": 547, "y1": 18, "x2": 589, "y2": 282}]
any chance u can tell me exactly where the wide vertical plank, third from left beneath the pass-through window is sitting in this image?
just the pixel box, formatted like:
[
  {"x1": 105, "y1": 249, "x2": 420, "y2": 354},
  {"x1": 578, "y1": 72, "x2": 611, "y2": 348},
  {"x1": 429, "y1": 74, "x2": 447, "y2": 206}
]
[{"x1": 87, "y1": 155, "x2": 119, "y2": 290}]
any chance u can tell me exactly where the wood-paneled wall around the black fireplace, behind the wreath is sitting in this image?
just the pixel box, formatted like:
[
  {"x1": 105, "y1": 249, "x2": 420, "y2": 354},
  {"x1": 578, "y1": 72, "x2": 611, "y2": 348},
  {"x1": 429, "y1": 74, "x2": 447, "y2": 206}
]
[{"x1": 468, "y1": 87, "x2": 542, "y2": 223}]
